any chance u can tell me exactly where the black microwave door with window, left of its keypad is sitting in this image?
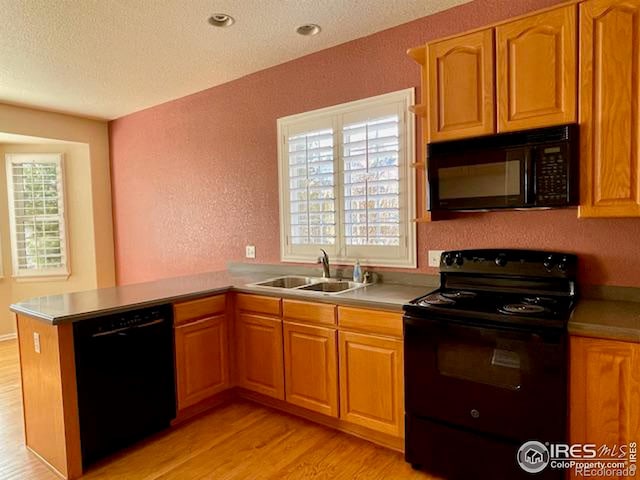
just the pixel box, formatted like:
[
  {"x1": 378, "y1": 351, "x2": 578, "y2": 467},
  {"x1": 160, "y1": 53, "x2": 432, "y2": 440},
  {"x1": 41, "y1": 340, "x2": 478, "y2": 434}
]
[{"x1": 428, "y1": 147, "x2": 534, "y2": 210}]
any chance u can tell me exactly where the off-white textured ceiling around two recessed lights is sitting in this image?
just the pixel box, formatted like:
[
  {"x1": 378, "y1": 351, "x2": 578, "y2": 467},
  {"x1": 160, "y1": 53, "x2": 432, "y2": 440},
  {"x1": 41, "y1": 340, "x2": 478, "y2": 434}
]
[{"x1": 0, "y1": 0, "x2": 470, "y2": 119}]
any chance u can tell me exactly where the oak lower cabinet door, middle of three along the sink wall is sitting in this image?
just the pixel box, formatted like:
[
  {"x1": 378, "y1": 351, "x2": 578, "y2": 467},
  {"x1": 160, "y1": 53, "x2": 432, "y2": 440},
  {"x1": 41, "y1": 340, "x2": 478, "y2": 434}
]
[{"x1": 284, "y1": 322, "x2": 338, "y2": 417}]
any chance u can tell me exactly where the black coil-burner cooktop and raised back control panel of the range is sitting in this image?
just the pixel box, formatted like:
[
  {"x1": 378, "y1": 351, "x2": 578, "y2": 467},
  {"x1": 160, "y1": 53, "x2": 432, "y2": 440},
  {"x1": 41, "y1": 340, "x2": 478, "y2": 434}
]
[{"x1": 404, "y1": 249, "x2": 577, "y2": 328}]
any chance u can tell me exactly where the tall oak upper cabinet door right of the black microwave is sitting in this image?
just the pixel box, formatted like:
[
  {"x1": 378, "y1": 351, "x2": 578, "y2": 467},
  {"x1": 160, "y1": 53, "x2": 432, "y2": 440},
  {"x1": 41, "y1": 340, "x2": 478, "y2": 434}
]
[{"x1": 579, "y1": 0, "x2": 640, "y2": 217}]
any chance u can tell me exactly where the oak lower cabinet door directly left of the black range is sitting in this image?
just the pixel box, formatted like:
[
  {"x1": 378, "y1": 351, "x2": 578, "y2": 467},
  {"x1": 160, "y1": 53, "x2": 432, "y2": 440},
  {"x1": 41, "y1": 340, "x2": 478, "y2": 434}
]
[{"x1": 339, "y1": 332, "x2": 404, "y2": 437}]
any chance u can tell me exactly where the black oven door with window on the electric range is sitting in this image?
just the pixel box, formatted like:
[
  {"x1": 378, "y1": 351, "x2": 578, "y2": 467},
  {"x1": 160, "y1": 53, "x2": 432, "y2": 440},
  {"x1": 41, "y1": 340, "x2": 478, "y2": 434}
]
[{"x1": 404, "y1": 316, "x2": 567, "y2": 441}]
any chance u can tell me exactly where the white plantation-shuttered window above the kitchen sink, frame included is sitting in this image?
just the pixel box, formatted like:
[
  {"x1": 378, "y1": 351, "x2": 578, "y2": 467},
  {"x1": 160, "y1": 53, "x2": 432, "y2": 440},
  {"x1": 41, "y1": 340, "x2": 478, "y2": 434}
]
[{"x1": 278, "y1": 89, "x2": 416, "y2": 267}]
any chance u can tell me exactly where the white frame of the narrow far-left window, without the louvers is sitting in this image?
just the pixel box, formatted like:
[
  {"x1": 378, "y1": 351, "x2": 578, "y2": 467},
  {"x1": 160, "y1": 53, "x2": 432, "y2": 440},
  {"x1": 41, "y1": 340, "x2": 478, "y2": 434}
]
[{"x1": 5, "y1": 153, "x2": 71, "y2": 281}]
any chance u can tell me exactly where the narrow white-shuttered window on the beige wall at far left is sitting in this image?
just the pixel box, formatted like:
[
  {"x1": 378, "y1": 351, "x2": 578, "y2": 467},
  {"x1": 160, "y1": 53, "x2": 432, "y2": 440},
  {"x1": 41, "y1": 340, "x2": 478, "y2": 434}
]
[{"x1": 6, "y1": 154, "x2": 69, "y2": 278}]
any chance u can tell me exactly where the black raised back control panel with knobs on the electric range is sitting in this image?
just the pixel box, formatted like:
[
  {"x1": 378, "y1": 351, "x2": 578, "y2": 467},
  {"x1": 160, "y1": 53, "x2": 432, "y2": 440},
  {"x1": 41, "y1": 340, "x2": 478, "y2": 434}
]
[{"x1": 440, "y1": 249, "x2": 578, "y2": 278}]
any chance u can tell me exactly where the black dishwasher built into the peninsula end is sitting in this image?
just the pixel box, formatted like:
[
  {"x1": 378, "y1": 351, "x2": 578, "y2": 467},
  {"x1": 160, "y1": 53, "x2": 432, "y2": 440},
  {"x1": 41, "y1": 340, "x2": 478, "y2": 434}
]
[{"x1": 73, "y1": 305, "x2": 176, "y2": 467}]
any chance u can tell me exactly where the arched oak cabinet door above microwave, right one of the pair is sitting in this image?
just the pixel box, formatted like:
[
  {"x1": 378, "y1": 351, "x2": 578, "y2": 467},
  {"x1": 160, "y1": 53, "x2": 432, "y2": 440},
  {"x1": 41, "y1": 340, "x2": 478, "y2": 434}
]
[{"x1": 496, "y1": 5, "x2": 578, "y2": 132}]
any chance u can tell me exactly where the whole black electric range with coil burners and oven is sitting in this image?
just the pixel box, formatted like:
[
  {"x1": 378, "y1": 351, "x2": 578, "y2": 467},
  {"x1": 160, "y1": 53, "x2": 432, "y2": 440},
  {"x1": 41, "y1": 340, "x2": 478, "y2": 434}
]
[{"x1": 404, "y1": 250, "x2": 577, "y2": 480}]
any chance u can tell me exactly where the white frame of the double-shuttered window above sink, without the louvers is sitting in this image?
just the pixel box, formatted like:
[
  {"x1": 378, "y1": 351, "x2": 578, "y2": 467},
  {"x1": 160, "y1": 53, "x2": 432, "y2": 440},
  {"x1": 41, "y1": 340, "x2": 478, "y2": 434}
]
[{"x1": 277, "y1": 88, "x2": 417, "y2": 268}]
